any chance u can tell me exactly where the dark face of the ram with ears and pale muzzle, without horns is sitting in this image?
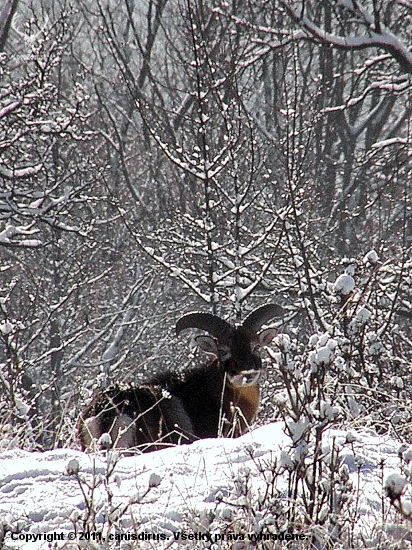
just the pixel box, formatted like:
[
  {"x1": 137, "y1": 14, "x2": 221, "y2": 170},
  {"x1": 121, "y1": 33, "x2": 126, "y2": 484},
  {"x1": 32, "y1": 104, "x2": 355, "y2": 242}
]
[{"x1": 196, "y1": 327, "x2": 276, "y2": 387}]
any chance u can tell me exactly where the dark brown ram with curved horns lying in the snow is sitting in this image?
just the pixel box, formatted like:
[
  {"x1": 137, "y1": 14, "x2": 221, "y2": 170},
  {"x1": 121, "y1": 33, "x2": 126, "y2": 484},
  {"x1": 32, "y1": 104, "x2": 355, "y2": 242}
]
[{"x1": 79, "y1": 304, "x2": 282, "y2": 451}]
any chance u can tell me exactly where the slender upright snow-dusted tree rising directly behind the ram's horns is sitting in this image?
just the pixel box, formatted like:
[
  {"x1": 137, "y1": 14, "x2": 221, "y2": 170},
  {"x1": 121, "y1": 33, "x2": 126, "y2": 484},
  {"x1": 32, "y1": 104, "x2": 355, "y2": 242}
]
[{"x1": 83, "y1": 2, "x2": 288, "y2": 315}]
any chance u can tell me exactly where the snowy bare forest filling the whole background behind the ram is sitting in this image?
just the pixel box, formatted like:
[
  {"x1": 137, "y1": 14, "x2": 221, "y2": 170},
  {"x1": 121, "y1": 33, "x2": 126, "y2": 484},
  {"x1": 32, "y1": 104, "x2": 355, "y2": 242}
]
[{"x1": 0, "y1": 0, "x2": 412, "y2": 468}]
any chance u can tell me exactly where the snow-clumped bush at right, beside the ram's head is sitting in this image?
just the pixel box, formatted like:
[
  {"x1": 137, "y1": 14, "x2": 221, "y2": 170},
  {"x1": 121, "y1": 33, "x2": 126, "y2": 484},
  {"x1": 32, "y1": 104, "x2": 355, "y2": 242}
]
[{"x1": 249, "y1": 253, "x2": 412, "y2": 547}]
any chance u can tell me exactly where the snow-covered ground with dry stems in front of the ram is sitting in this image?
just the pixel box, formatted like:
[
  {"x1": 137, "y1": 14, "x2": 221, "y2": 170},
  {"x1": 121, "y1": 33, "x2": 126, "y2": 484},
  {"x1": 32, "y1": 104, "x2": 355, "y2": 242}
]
[{"x1": 0, "y1": 422, "x2": 412, "y2": 550}]
